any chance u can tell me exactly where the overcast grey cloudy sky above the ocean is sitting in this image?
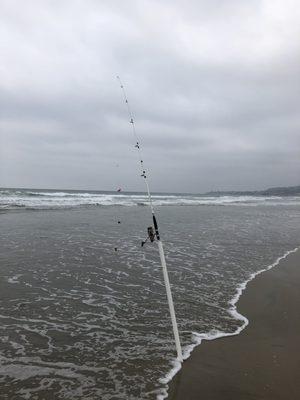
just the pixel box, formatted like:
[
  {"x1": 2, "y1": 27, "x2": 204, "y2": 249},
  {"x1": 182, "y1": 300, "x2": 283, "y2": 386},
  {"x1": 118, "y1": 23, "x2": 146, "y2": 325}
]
[{"x1": 0, "y1": 0, "x2": 300, "y2": 192}]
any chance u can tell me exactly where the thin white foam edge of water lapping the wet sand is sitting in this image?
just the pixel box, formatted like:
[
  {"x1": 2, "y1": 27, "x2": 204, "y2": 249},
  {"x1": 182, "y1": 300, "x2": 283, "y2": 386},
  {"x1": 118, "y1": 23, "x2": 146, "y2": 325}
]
[{"x1": 157, "y1": 247, "x2": 299, "y2": 400}]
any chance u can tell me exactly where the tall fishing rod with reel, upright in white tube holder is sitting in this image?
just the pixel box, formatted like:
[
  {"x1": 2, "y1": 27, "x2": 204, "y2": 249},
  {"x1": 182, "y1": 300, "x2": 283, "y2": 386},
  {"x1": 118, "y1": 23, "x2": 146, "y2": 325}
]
[{"x1": 117, "y1": 76, "x2": 183, "y2": 362}]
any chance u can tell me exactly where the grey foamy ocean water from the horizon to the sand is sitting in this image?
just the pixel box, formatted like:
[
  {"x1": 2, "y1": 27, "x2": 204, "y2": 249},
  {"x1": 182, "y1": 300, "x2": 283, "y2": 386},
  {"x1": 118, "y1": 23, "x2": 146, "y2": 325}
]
[{"x1": 0, "y1": 189, "x2": 300, "y2": 400}]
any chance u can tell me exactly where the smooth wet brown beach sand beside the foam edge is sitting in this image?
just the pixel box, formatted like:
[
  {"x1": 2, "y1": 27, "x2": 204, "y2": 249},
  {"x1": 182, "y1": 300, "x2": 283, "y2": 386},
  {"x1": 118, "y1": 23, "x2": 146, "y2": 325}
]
[{"x1": 168, "y1": 250, "x2": 300, "y2": 400}]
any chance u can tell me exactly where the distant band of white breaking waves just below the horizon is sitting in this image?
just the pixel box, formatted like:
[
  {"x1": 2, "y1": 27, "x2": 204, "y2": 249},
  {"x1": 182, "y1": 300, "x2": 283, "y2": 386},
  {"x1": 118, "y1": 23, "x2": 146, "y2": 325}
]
[{"x1": 0, "y1": 189, "x2": 300, "y2": 209}]
